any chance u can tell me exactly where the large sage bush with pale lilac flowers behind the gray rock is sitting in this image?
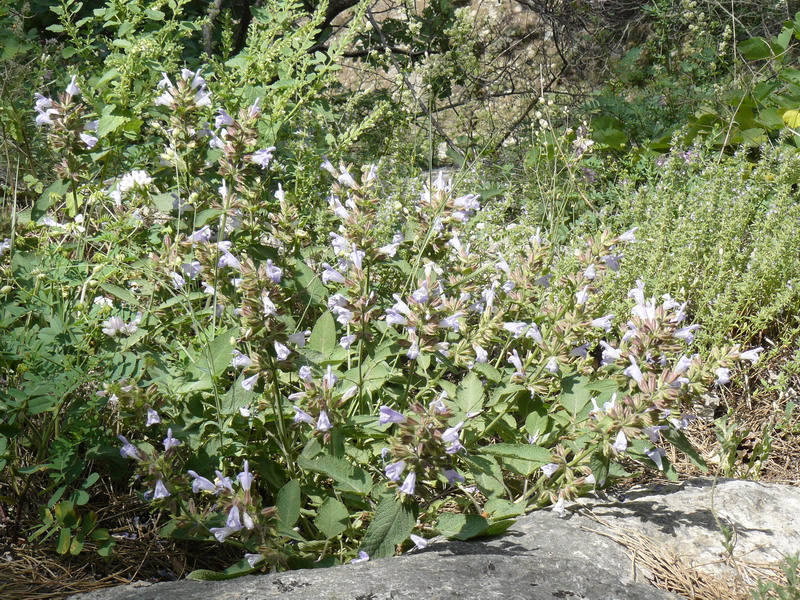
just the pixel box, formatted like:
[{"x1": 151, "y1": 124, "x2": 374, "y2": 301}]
[{"x1": 14, "y1": 70, "x2": 760, "y2": 577}]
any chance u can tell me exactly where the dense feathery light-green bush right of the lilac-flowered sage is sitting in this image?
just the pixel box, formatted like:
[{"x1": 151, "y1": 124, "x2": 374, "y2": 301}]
[{"x1": 606, "y1": 148, "x2": 800, "y2": 352}]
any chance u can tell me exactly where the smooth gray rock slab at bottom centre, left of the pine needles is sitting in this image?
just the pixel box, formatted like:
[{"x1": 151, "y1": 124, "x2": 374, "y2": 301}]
[{"x1": 73, "y1": 512, "x2": 678, "y2": 600}]
